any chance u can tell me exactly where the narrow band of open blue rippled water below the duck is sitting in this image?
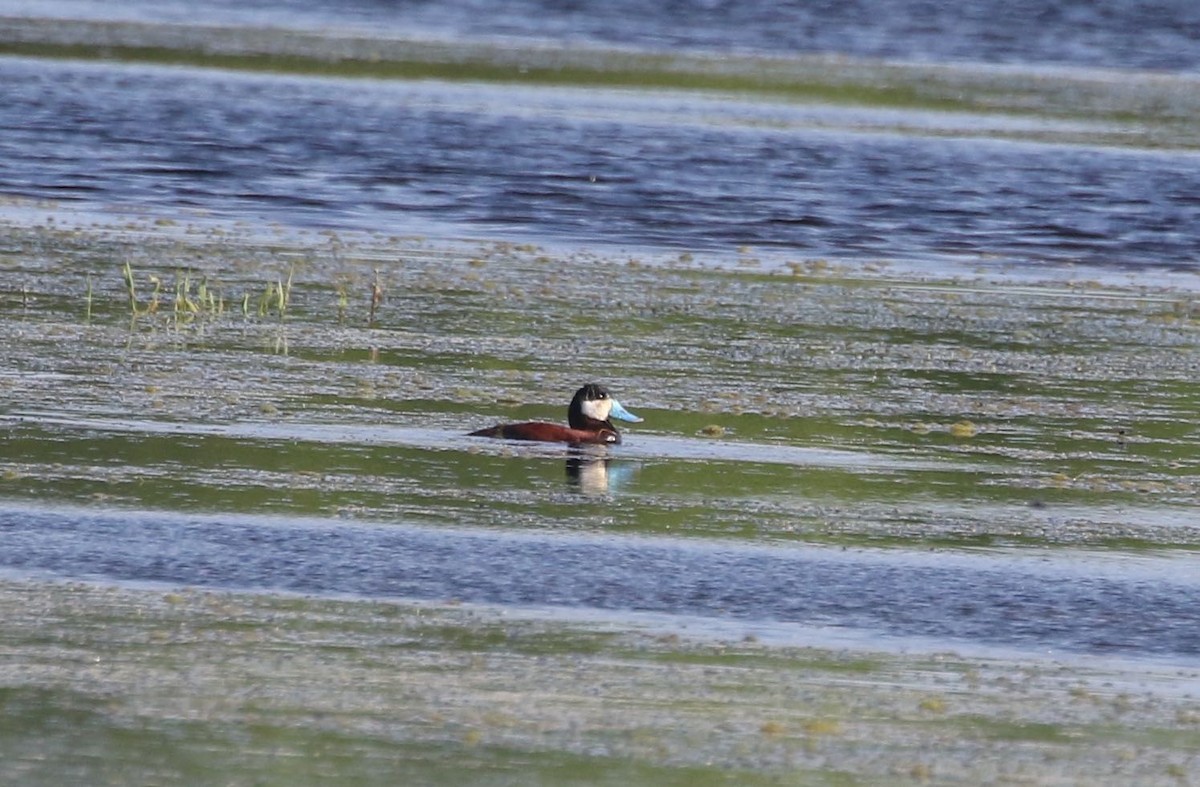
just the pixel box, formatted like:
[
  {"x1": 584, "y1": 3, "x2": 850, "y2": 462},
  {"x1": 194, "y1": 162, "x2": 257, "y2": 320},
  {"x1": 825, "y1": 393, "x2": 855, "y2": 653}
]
[{"x1": 0, "y1": 509, "x2": 1200, "y2": 660}]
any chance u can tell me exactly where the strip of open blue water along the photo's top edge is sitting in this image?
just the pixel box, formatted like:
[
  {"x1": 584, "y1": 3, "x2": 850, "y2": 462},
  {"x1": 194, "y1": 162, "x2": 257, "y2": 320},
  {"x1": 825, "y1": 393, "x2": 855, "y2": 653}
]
[{"x1": 14, "y1": 0, "x2": 1200, "y2": 71}]
